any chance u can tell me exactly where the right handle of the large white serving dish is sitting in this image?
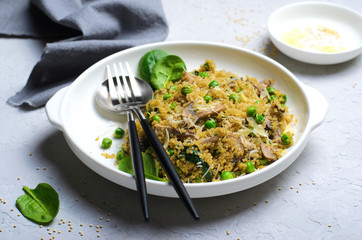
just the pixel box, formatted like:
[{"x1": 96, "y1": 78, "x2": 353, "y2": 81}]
[{"x1": 304, "y1": 85, "x2": 328, "y2": 130}]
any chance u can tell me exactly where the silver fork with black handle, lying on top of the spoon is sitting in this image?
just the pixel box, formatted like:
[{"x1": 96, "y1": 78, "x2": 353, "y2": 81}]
[{"x1": 107, "y1": 62, "x2": 199, "y2": 220}]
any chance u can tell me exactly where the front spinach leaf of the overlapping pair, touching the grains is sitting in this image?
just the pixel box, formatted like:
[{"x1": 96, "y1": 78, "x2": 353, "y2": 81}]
[{"x1": 151, "y1": 55, "x2": 186, "y2": 90}]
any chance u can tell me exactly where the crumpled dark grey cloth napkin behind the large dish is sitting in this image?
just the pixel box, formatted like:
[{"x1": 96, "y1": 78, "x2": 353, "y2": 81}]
[{"x1": 0, "y1": 0, "x2": 168, "y2": 107}]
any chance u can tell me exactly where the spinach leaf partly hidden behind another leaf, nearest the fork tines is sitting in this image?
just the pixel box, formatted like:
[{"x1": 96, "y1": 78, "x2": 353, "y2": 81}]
[{"x1": 138, "y1": 49, "x2": 168, "y2": 84}]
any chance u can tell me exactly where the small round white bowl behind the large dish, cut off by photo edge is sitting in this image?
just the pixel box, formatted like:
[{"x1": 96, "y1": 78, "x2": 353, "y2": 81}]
[{"x1": 267, "y1": 2, "x2": 362, "y2": 65}]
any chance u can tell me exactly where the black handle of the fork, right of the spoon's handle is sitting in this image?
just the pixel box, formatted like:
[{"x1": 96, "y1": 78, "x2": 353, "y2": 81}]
[{"x1": 134, "y1": 108, "x2": 200, "y2": 220}]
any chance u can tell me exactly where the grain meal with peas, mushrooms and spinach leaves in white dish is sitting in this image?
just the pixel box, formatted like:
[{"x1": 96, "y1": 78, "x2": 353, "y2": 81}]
[{"x1": 111, "y1": 50, "x2": 296, "y2": 183}]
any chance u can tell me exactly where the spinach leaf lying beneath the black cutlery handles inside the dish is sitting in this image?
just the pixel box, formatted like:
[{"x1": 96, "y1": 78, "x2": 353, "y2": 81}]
[{"x1": 118, "y1": 153, "x2": 166, "y2": 182}]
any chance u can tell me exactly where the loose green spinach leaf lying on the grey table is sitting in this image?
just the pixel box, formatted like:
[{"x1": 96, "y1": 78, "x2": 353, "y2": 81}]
[{"x1": 16, "y1": 183, "x2": 59, "y2": 224}]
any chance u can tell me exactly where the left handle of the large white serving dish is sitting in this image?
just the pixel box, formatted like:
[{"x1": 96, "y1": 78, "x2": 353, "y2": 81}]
[{"x1": 45, "y1": 87, "x2": 68, "y2": 132}]
